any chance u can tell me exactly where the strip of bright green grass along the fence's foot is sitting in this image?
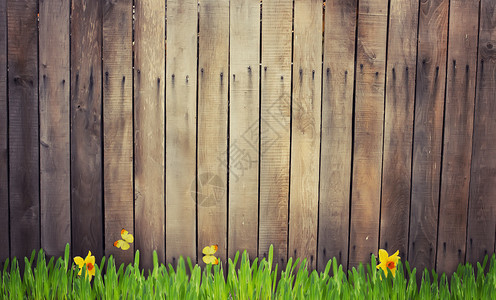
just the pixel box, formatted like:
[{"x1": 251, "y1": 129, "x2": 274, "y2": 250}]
[{"x1": 0, "y1": 245, "x2": 496, "y2": 299}]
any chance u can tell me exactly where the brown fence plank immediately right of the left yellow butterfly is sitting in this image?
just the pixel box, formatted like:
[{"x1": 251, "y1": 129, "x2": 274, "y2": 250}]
[{"x1": 134, "y1": 0, "x2": 165, "y2": 269}]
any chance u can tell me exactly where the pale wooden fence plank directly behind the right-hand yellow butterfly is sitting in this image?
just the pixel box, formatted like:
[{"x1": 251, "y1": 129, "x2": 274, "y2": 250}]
[{"x1": 197, "y1": 0, "x2": 229, "y2": 261}]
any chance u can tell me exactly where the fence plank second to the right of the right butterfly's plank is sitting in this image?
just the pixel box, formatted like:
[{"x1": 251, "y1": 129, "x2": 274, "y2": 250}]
[{"x1": 258, "y1": 0, "x2": 293, "y2": 266}]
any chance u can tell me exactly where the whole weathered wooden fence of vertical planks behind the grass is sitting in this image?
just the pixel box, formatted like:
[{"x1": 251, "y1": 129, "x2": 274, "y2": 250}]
[{"x1": 0, "y1": 0, "x2": 496, "y2": 272}]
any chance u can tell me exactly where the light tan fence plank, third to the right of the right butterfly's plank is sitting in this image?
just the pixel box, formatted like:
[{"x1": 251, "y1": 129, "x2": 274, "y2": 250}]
[{"x1": 289, "y1": 0, "x2": 322, "y2": 269}]
